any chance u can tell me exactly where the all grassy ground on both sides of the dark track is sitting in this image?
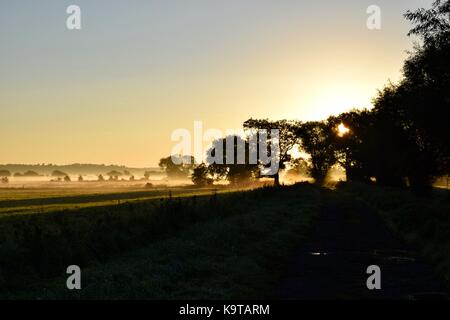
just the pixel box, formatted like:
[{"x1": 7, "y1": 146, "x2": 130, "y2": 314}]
[{"x1": 0, "y1": 184, "x2": 450, "y2": 299}]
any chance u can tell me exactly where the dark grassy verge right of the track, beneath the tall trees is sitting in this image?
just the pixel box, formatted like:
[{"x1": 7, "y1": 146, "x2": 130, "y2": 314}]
[{"x1": 337, "y1": 184, "x2": 450, "y2": 287}]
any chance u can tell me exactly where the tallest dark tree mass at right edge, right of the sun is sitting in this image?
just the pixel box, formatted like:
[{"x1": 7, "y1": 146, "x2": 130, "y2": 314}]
[{"x1": 356, "y1": 1, "x2": 450, "y2": 193}]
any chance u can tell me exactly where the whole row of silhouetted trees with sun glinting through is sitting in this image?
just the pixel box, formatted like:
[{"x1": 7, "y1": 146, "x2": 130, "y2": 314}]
[{"x1": 166, "y1": 1, "x2": 450, "y2": 193}]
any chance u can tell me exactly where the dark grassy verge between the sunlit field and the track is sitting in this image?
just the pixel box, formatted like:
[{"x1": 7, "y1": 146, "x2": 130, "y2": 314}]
[{"x1": 0, "y1": 186, "x2": 320, "y2": 299}]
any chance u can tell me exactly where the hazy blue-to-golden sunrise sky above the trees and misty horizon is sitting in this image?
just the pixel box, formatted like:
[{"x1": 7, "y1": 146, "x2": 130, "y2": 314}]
[{"x1": 0, "y1": 0, "x2": 432, "y2": 167}]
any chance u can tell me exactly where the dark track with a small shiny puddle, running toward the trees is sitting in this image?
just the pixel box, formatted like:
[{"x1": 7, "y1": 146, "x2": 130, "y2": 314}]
[{"x1": 275, "y1": 191, "x2": 448, "y2": 300}]
